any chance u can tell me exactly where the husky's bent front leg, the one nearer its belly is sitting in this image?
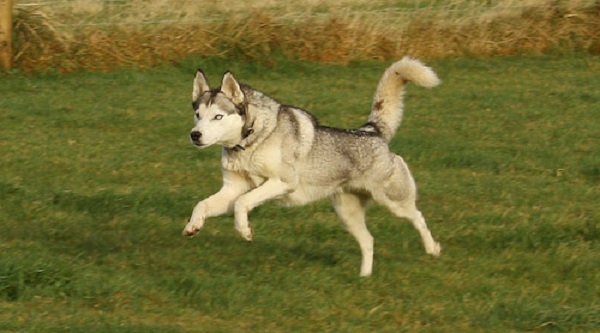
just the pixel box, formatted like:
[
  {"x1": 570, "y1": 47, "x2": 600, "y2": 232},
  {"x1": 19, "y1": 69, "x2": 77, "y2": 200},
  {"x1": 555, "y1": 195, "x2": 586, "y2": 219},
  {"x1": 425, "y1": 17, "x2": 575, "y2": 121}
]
[{"x1": 234, "y1": 178, "x2": 292, "y2": 242}]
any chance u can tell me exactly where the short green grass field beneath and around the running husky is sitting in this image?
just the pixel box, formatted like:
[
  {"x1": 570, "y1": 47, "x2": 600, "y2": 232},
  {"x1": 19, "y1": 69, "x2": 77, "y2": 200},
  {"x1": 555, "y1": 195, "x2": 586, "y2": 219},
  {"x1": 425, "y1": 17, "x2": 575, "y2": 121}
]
[{"x1": 0, "y1": 56, "x2": 600, "y2": 332}]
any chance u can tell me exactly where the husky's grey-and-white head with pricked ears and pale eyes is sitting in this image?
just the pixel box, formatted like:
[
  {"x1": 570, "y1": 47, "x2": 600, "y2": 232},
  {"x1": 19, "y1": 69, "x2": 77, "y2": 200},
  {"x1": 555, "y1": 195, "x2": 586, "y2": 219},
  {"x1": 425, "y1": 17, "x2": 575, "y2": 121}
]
[{"x1": 190, "y1": 69, "x2": 246, "y2": 148}]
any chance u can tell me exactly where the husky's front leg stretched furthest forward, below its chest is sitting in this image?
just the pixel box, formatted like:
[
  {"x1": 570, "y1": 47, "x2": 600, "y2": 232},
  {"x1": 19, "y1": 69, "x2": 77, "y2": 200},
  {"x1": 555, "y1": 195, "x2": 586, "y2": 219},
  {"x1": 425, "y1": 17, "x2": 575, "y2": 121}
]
[{"x1": 183, "y1": 171, "x2": 251, "y2": 236}]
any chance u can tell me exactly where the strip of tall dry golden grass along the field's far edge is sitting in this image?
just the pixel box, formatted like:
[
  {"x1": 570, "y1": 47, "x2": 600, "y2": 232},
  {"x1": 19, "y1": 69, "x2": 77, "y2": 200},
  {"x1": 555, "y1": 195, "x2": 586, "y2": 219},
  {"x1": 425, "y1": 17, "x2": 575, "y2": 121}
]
[{"x1": 9, "y1": 0, "x2": 600, "y2": 71}]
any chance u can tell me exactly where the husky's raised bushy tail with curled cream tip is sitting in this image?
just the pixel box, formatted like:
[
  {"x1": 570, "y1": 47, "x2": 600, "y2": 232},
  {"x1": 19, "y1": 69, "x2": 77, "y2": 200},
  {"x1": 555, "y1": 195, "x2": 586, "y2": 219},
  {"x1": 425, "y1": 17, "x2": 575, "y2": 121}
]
[{"x1": 368, "y1": 57, "x2": 440, "y2": 142}]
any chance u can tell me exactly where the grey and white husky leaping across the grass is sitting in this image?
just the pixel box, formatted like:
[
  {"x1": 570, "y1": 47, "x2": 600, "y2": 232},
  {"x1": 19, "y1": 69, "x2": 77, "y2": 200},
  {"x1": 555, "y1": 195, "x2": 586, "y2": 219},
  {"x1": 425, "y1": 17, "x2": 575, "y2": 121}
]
[{"x1": 183, "y1": 57, "x2": 441, "y2": 276}]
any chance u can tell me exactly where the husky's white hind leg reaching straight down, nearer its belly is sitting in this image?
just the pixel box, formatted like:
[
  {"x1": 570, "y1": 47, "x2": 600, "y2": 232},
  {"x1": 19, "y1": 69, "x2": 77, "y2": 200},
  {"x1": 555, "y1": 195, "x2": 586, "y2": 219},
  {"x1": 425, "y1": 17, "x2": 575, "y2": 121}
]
[{"x1": 333, "y1": 193, "x2": 373, "y2": 276}]
